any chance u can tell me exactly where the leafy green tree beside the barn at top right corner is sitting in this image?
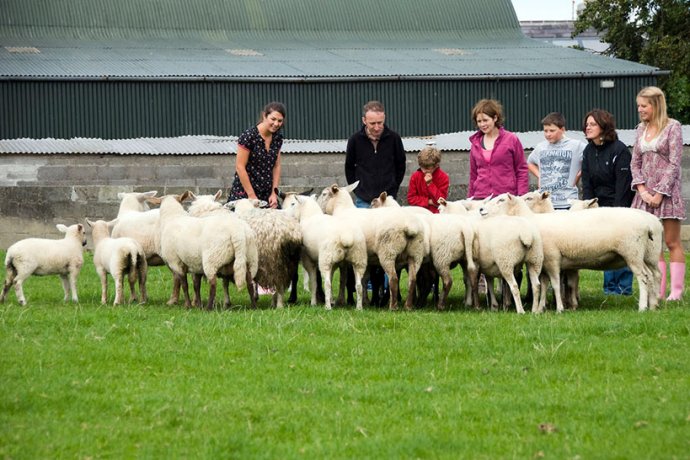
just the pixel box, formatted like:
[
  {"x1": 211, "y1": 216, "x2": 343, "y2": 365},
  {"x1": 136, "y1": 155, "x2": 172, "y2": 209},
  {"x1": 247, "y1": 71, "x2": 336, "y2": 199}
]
[{"x1": 574, "y1": 0, "x2": 690, "y2": 124}]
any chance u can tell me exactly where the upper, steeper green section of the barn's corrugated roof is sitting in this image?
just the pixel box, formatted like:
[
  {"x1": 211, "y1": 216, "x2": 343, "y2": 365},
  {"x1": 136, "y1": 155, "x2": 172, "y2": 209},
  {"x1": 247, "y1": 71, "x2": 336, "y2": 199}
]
[{"x1": 0, "y1": 0, "x2": 519, "y2": 38}]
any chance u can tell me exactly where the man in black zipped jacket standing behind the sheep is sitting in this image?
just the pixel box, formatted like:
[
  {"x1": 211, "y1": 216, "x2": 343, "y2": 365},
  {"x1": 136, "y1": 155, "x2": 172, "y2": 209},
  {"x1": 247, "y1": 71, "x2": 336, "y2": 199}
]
[{"x1": 345, "y1": 101, "x2": 406, "y2": 208}]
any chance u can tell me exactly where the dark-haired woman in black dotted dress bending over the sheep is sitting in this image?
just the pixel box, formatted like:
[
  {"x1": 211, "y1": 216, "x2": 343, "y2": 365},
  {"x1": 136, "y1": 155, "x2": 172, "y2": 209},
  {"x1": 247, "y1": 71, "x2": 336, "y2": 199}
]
[{"x1": 228, "y1": 102, "x2": 286, "y2": 208}]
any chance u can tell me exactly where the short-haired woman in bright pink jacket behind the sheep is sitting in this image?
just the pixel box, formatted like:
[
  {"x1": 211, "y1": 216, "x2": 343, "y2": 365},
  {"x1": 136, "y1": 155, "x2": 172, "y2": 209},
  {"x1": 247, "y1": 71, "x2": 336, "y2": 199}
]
[{"x1": 467, "y1": 99, "x2": 529, "y2": 198}]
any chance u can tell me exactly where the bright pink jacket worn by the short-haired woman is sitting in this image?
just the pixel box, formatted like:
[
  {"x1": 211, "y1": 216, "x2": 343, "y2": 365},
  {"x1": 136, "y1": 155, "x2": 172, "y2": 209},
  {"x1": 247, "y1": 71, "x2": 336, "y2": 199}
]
[{"x1": 467, "y1": 127, "x2": 529, "y2": 198}]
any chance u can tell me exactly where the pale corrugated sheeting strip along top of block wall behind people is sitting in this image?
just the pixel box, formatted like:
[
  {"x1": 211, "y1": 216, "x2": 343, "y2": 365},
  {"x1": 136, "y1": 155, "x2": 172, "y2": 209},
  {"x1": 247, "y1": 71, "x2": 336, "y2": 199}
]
[{"x1": 0, "y1": 125, "x2": 690, "y2": 155}]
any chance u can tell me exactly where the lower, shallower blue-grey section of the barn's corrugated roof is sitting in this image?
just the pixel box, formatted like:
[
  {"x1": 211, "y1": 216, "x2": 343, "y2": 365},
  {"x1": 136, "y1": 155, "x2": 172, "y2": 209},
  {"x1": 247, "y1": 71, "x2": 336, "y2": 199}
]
[{"x1": 0, "y1": 36, "x2": 658, "y2": 79}]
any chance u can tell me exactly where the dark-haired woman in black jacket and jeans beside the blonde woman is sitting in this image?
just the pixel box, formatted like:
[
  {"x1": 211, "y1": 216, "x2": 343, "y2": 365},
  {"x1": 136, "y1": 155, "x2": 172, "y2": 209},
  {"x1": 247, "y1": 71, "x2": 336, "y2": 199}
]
[{"x1": 582, "y1": 109, "x2": 634, "y2": 295}]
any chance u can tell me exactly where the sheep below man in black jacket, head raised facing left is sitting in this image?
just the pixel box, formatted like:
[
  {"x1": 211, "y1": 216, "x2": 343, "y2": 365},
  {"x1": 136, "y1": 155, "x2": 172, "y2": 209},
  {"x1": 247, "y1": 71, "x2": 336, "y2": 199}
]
[{"x1": 317, "y1": 182, "x2": 428, "y2": 310}]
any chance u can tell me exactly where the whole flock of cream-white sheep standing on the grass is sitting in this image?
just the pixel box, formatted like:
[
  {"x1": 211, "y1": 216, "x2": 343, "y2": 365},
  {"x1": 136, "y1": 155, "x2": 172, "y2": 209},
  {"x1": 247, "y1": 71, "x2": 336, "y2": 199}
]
[{"x1": 0, "y1": 183, "x2": 663, "y2": 313}]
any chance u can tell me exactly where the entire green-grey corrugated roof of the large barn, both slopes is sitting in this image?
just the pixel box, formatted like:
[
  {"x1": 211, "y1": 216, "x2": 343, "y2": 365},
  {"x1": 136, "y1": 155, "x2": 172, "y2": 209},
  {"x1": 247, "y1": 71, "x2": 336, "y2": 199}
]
[{"x1": 0, "y1": 0, "x2": 659, "y2": 81}]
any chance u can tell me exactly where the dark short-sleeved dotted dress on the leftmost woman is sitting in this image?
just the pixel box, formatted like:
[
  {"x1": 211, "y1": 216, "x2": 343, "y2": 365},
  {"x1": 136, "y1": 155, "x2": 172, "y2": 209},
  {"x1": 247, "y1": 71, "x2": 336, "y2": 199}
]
[{"x1": 228, "y1": 126, "x2": 283, "y2": 201}]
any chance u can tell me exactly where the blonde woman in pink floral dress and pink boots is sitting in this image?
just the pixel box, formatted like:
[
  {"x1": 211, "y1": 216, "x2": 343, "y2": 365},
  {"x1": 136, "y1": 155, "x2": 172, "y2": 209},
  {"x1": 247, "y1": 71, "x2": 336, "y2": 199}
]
[{"x1": 630, "y1": 86, "x2": 685, "y2": 300}]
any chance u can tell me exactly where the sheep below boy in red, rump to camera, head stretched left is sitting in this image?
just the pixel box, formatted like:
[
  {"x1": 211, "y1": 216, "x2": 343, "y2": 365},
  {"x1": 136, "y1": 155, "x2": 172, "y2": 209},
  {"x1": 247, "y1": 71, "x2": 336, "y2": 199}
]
[{"x1": 372, "y1": 192, "x2": 476, "y2": 310}]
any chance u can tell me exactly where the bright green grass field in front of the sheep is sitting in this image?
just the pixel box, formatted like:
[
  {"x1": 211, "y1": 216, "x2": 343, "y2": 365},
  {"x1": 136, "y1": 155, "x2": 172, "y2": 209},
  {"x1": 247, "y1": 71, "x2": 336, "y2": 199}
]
[{"x1": 0, "y1": 254, "x2": 690, "y2": 459}]
